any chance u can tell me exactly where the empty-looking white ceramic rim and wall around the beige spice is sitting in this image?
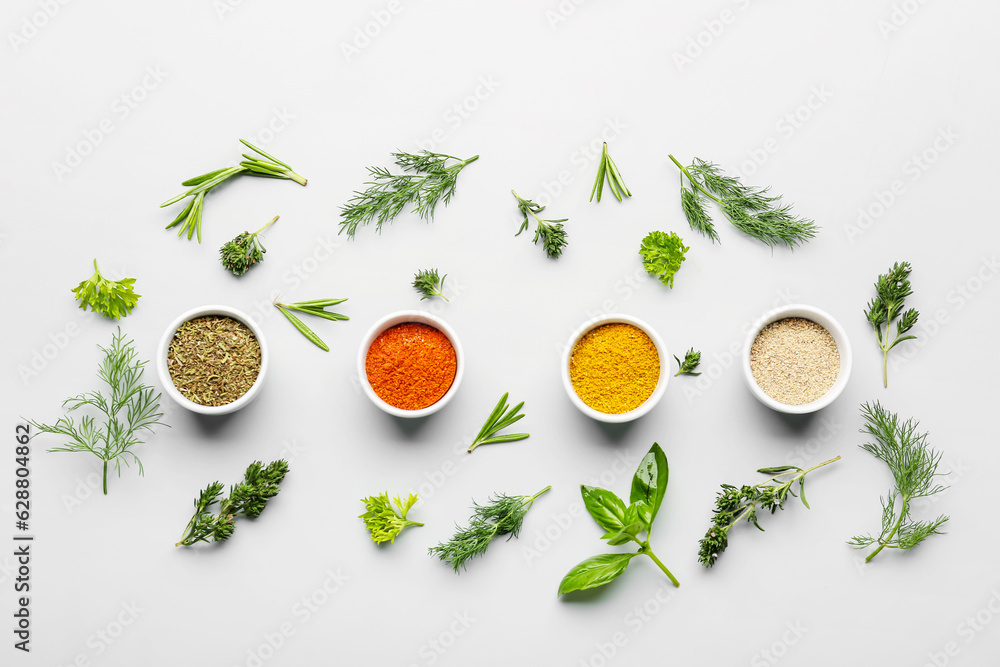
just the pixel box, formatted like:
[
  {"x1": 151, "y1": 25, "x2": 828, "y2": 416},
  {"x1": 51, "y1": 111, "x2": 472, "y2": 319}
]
[{"x1": 743, "y1": 303, "x2": 854, "y2": 415}]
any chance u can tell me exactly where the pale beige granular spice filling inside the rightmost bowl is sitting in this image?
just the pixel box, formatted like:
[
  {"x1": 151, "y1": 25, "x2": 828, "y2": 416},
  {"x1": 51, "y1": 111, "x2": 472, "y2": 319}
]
[{"x1": 750, "y1": 317, "x2": 840, "y2": 405}]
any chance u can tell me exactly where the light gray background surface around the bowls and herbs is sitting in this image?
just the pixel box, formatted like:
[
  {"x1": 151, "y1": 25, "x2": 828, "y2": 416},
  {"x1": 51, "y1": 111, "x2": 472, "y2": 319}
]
[{"x1": 0, "y1": 0, "x2": 1000, "y2": 666}]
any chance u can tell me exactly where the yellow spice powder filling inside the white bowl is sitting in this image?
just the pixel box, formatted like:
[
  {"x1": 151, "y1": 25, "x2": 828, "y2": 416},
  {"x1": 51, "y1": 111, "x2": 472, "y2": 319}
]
[{"x1": 569, "y1": 324, "x2": 660, "y2": 414}]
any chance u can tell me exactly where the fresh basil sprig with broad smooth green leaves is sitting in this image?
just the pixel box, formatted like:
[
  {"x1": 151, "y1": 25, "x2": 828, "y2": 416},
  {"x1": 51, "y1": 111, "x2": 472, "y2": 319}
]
[{"x1": 559, "y1": 443, "x2": 680, "y2": 595}]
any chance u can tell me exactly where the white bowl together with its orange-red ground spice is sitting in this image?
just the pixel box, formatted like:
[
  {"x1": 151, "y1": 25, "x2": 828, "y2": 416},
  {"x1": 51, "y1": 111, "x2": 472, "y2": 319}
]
[{"x1": 358, "y1": 310, "x2": 465, "y2": 418}]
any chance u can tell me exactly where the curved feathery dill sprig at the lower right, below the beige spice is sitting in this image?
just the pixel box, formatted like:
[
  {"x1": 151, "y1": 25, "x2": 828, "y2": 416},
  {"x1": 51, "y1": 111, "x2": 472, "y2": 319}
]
[{"x1": 848, "y1": 401, "x2": 948, "y2": 563}]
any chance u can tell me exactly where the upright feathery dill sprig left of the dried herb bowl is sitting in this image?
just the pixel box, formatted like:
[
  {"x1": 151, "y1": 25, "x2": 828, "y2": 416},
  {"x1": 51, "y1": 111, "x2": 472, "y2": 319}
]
[{"x1": 30, "y1": 328, "x2": 166, "y2": 495}]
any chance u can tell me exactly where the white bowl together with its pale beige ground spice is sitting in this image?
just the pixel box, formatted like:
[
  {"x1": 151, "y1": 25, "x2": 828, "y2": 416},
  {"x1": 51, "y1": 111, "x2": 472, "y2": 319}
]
[{"x1": 743, "y1": 304, "x2": 852, "y2": 414}]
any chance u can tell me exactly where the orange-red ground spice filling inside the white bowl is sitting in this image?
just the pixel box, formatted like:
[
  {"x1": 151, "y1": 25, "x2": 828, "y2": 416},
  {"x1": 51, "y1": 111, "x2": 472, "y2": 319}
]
[{"x1": 365, "y1": 322, "x2": 458, "y2": 410}]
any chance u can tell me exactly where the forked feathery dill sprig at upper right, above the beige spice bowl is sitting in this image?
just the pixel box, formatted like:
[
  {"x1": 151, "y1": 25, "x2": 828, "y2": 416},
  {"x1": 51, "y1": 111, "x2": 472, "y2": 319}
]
[{"x1": 668, "y1": 155, "x2": 819, "y2": 248}]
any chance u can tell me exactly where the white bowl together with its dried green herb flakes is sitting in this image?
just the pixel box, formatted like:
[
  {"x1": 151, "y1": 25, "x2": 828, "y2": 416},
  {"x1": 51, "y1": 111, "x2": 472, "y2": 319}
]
[{"x1": 156, "y1": 305, "x2": 268, "y2": 415}]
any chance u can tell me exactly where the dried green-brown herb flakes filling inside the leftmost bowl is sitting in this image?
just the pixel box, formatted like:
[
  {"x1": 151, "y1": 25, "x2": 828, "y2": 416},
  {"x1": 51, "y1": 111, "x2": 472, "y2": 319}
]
[{"x1": 167, "y1": 315, "x2": 261, "y2": 407}]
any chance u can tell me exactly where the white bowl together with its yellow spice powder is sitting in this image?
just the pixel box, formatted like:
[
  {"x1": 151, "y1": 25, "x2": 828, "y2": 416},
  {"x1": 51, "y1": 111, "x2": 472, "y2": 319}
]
[{"x1": 562, "y1": 315, "x2": 670, "y2": 423}]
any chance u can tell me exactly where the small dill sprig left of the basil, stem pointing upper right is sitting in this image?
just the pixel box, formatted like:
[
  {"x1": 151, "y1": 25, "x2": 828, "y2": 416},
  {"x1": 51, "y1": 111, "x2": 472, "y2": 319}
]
[{"x1": 428, "y1": 486, "x2": 552, "y2": 574}]
